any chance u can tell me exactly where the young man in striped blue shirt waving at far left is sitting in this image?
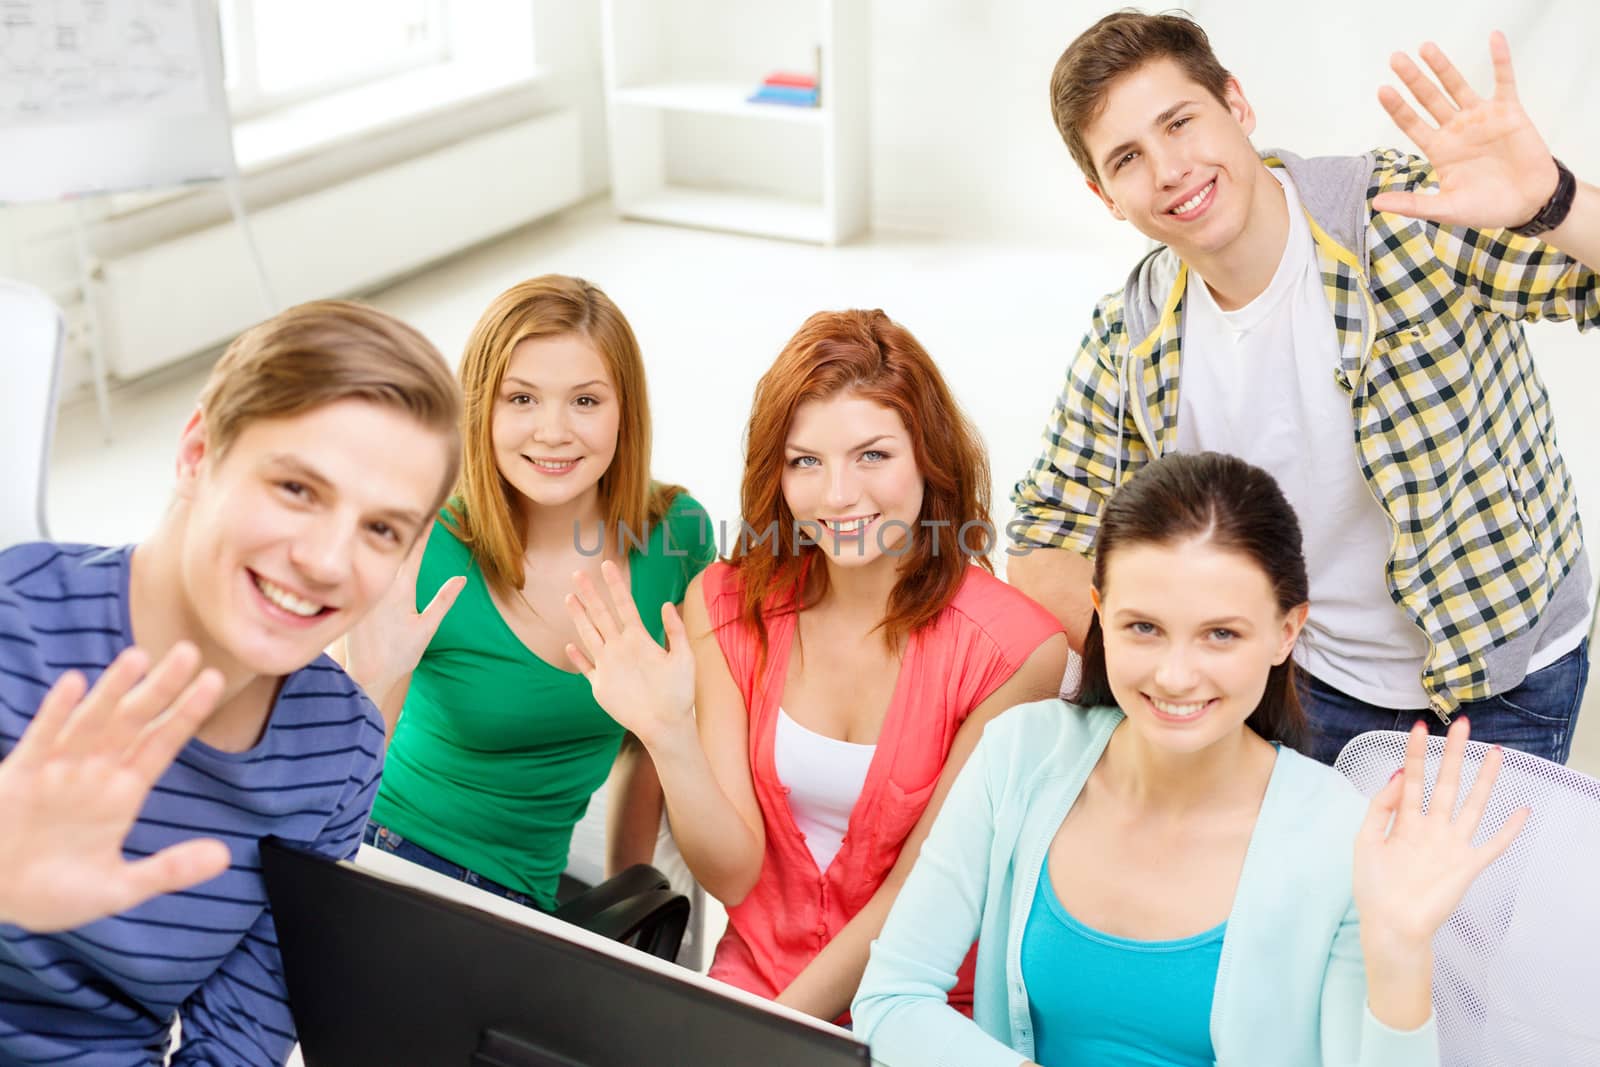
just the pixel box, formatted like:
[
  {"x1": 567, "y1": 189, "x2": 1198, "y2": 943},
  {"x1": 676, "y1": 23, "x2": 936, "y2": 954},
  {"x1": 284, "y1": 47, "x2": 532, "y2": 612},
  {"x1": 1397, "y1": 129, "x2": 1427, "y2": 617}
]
[{"x1": 0, "y1": 301, "x2": 459, "y2": 1067}]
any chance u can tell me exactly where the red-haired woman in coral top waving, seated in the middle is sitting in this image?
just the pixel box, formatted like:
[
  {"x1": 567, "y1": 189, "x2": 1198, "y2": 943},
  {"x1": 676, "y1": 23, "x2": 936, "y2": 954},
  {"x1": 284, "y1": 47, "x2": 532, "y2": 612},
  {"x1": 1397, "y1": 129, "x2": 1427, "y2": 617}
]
[{"x1": 568, "y1": 310, "x2": 1067, "y2": 1019}]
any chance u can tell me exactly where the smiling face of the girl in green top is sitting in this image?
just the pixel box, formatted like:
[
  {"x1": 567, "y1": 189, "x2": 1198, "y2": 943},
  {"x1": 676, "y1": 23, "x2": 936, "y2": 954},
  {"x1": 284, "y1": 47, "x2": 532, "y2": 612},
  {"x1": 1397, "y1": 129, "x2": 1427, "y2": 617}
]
[{"x1": 491, "y1": 334, "x2": 621, "y2": 518}]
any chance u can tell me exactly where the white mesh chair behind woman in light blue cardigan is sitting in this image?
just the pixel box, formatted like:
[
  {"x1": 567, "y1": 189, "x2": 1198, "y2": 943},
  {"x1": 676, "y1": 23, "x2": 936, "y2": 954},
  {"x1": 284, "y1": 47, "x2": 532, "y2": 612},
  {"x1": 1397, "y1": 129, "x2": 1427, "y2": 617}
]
[{"x1": 1334, "y1": 731, "x2": 1600, "y2": 1067}]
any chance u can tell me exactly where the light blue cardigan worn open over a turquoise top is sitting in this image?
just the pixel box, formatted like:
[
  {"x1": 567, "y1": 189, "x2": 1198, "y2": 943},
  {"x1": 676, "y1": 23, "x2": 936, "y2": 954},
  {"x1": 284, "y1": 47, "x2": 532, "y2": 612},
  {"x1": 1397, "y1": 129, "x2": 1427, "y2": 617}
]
[{"x1": 851, "y1": 701, "x2": 1438, "y2": 1067}]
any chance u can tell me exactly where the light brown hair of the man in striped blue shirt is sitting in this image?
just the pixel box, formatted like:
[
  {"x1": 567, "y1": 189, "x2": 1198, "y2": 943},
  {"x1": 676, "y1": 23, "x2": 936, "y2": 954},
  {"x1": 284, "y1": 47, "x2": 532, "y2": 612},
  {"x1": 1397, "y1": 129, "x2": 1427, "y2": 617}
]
[{"x1": 200, "y1": 301, "x2": 461, "y2": 507}]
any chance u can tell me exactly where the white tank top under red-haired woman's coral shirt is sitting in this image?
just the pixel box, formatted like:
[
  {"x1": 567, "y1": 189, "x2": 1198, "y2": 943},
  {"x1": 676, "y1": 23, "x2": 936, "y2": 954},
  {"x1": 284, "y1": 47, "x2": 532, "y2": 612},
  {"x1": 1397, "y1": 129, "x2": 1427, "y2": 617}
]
[{"x1": 773, "y1": 707, "x2": 878, "y2": 870}]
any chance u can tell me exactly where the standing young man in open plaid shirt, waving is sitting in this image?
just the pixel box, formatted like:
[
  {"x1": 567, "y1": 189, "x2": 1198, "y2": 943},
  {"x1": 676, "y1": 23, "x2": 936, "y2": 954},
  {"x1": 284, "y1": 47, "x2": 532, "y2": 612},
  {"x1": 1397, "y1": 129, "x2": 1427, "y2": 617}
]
[{"x1": 1008, "y1": 13, "x2": 1600, "y2": 761}]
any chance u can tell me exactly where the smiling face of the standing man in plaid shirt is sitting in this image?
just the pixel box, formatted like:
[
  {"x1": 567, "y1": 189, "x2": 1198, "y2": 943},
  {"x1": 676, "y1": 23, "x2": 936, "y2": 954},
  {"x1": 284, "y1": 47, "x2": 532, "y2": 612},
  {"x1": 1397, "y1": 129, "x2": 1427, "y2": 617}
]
[{"x1": 1083, "y1": 59, "x2": 1272, "y2": 261}]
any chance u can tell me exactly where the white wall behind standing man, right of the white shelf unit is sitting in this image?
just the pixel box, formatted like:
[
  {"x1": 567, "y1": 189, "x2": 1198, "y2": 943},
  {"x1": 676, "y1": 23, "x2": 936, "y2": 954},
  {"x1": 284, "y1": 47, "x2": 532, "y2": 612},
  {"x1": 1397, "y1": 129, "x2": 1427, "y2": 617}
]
[{"x1": 870, "y1": 0, "x2": 1600, "y2": 246}]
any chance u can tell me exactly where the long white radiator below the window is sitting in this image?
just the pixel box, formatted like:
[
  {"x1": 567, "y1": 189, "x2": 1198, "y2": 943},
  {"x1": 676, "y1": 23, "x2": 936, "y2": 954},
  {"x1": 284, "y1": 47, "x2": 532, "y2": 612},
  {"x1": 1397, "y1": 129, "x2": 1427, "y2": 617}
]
[{"x1": 96, "y1": 110, "x2": 582, "y2": 379}]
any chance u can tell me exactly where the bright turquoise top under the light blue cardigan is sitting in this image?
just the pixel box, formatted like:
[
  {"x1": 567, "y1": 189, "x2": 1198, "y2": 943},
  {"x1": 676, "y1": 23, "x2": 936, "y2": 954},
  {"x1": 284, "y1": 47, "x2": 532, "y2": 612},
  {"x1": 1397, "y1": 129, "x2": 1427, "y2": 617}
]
[{"x1": 1022, "y1": 862, "x2": 1227, "y2": 1067}]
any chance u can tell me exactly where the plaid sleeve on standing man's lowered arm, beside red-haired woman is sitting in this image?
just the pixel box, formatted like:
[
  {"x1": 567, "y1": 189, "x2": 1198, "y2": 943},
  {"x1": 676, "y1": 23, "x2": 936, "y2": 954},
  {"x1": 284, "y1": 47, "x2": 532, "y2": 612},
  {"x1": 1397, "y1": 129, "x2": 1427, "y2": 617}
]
[{"x1": 1006, "y1": 293, "x2": 1149, "y2": 555}]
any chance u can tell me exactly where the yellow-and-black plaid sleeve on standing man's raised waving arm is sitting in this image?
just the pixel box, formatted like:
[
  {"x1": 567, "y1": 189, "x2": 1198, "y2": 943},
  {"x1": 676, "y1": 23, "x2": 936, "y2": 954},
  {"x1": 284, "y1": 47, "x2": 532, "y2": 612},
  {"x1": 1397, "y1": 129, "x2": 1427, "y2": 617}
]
[{"x1": 1379, "y1": 152, "x2": 1600, "y2": 330}]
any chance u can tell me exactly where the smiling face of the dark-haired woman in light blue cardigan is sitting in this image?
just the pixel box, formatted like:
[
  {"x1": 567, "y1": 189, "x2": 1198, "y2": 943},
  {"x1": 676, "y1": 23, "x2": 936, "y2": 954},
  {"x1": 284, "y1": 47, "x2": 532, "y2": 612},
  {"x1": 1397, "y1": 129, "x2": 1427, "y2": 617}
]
[{"x1": 1096, "y1": 539, "x2": 1306, "y2": 752}]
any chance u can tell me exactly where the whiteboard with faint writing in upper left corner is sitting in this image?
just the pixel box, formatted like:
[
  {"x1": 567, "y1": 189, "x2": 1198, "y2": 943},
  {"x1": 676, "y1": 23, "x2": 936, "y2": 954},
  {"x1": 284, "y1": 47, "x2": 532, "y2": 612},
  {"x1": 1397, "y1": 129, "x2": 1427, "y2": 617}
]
[{"x1": 0, "y1": 0, "x2": 234, "y2": 202}]
